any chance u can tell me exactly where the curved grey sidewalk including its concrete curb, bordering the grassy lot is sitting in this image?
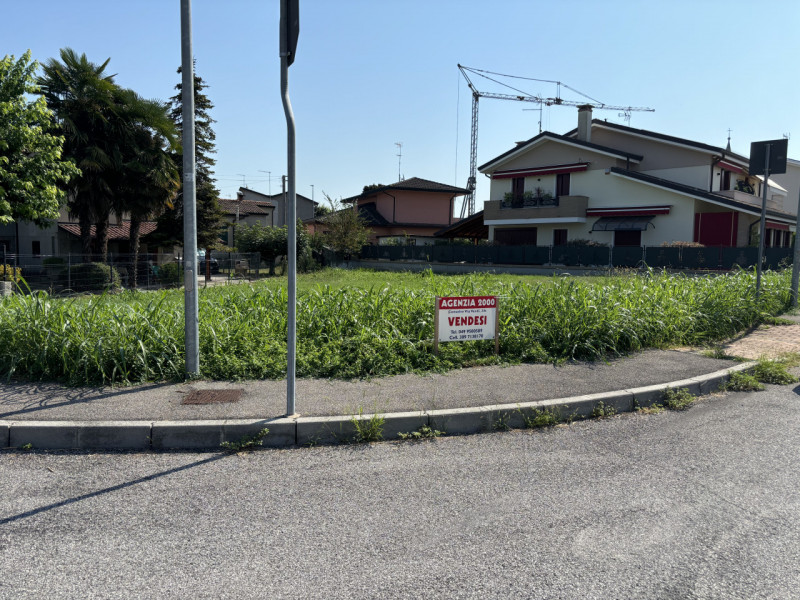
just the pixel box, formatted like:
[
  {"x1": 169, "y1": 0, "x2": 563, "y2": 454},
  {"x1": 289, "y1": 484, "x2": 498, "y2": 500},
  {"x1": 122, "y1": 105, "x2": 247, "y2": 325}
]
[{"x1": 0, "y1": 317, "x2": 800, "y2": 449}]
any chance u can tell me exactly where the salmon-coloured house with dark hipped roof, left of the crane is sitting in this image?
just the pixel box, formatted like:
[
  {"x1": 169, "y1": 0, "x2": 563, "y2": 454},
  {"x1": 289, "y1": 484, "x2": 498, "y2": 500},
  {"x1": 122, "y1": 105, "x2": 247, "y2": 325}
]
[{"x1": 342, "y1": 177, "x2": 469, "y2": 245}]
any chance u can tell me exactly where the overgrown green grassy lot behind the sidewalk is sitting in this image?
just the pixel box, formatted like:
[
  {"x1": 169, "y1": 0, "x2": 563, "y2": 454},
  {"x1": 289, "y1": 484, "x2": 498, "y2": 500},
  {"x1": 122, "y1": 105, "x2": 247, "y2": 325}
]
[{"x1": 0, "y1": 270, "x2": 790, "y2": 384}]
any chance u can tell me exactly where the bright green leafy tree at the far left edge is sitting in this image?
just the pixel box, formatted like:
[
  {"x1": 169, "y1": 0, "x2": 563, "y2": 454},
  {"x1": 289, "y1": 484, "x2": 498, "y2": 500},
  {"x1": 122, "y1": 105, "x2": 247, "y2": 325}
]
[{"x1": 0, "y1": 50, "x2": 80, "y2": 226}]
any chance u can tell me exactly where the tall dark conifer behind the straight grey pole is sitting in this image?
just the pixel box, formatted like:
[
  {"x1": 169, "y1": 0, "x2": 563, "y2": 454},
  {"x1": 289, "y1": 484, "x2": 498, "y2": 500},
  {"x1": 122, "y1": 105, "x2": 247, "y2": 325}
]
[{"x1": 148, "y1": 68, "x2": 225, "y2": 250}]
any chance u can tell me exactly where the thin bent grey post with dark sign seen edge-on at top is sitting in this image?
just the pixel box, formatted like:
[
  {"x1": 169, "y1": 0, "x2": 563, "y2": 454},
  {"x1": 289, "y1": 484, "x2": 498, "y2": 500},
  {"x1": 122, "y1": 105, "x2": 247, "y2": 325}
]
[{"x1": 280, "y1": 0, "x2": 300, "y2": 416}]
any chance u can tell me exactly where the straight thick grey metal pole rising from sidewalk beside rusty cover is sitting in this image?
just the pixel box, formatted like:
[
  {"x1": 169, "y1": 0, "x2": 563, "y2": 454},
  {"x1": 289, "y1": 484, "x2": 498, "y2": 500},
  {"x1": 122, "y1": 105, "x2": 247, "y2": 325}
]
[{"x1": 181, "y1": 0, "x2": 200, "y2": 376}]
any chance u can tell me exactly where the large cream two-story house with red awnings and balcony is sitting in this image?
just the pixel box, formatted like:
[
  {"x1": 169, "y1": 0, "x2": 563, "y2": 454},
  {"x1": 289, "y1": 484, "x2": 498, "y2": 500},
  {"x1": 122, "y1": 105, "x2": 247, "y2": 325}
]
[{"x1": 480, "y1": 107, "x2": 796, "y2": 246}]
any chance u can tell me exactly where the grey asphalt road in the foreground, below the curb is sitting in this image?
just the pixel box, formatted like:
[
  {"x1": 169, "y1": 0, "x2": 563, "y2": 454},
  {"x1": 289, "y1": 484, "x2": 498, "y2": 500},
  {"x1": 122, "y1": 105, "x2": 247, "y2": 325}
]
[{"x1": 0, "y1": 386, "x2": 800, "y2": 599}]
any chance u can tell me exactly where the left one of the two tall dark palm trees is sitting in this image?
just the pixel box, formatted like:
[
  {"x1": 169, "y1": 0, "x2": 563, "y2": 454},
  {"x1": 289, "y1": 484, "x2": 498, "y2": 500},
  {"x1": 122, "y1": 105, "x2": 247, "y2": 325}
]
[{"x1": 38, "y1": 48, "x2": 119, "y2": 255}]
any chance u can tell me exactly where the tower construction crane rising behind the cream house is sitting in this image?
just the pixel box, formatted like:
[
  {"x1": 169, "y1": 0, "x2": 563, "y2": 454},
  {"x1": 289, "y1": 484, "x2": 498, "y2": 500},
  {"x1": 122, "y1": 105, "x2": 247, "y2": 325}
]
[{"x1": 458, "y1": 64, "x2": 655, "y2": 218}]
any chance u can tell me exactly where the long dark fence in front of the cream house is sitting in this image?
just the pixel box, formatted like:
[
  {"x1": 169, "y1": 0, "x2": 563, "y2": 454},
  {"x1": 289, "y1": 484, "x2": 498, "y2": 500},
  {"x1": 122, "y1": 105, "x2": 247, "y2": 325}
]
[{"x1": 361, "y1": 244, "x2": 794, "y2": 270}]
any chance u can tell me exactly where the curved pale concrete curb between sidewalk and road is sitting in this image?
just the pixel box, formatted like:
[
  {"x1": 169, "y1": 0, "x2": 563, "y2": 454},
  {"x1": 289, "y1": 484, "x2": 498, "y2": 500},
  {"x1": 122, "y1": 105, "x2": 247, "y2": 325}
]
[{"x1": 0, "y1": 362, "x2": 756, "y2": 450}]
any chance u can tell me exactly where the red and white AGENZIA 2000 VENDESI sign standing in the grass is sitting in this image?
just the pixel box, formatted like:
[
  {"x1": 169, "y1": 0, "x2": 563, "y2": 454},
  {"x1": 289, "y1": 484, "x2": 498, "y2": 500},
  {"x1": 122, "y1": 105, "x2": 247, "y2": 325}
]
[{"x1": 434, "y1": 296, "x2": 498, "y2": 352}]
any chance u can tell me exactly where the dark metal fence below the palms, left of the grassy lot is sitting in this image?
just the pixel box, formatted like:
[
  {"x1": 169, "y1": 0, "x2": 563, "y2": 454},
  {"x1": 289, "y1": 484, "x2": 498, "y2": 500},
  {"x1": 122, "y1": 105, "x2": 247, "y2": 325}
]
[{"x1": 0, "y1": 252, "x2": 262, "y2": 294}]
